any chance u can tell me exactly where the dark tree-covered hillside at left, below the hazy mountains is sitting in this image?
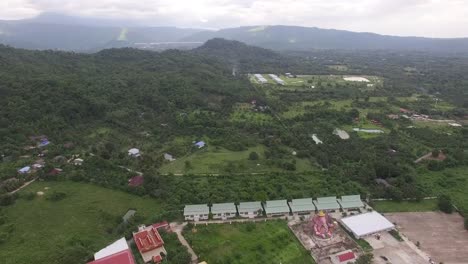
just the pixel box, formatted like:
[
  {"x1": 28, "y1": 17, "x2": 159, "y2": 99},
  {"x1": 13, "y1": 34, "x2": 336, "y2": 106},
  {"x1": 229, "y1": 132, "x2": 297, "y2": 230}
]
[{"x1": 0, "y1": 46, "x2": 249, "y2": 152}]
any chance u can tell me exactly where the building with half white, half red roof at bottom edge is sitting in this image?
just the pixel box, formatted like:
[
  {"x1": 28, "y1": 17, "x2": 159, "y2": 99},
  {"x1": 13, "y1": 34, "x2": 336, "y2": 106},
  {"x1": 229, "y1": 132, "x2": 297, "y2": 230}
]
[{"x1": 88, "y1": 237, "x2": 135, "y2": 264}]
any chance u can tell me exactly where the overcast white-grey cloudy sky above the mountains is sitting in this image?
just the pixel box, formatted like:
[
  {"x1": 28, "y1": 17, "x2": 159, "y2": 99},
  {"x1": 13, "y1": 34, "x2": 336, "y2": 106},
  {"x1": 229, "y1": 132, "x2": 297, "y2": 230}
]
[{"x1": 0, "y1": 0, "x2": 468, "y2": 37}]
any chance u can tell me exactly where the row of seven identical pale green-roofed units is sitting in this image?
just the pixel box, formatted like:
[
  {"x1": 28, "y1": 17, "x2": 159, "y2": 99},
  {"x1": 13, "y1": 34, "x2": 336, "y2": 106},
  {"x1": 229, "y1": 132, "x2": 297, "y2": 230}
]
[{"x1": 184, "y1": 195, "x2": 364, "y2": 221}]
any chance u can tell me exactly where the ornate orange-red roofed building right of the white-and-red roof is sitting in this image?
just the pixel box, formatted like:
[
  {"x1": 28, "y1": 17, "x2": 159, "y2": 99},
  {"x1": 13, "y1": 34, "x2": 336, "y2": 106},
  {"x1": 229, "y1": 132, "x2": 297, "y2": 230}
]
[{"x1": 133, "y1": 225, "x2": 167, "y2": 263}]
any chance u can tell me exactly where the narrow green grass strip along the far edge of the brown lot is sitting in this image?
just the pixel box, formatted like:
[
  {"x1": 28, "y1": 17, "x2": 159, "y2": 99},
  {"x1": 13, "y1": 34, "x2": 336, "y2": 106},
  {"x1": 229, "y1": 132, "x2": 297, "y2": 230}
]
[{"x1": 373, "y1": 199, "x2": 437, "y2": 213}]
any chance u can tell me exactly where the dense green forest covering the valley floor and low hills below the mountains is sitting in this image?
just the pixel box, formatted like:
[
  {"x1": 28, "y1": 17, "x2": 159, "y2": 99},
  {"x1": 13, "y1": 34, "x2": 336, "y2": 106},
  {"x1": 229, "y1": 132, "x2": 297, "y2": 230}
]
[{"x1": 0, "y1": 39, "x2": 468, "y2": 212}]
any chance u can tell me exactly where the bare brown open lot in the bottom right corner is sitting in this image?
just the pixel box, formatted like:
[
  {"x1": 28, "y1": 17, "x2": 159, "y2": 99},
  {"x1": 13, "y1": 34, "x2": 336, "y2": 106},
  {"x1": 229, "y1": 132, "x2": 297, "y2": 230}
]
[{"x1": 384, "y1": 212, "x2": 468, "y2": 264}]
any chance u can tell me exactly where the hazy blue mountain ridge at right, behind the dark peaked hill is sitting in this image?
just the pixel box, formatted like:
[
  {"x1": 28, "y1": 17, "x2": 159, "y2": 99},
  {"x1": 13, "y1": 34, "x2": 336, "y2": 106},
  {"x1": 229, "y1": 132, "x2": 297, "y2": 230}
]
[{"x1": 184, "y1": 26, "x2": 468, "y2": 53}]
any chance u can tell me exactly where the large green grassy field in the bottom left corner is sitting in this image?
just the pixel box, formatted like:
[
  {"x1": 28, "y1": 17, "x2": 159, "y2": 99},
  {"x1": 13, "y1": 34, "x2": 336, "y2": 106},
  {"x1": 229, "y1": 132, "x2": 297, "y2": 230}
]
[{"x1": 0, "y1": 181, "x2": 161, "y2": 264}]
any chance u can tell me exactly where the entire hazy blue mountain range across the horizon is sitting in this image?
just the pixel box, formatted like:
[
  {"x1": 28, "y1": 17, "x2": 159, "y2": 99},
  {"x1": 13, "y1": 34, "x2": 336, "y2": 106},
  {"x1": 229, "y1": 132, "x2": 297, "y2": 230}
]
[{"x1": 0, "y1": 13, "x2": 468, "y2": 53}]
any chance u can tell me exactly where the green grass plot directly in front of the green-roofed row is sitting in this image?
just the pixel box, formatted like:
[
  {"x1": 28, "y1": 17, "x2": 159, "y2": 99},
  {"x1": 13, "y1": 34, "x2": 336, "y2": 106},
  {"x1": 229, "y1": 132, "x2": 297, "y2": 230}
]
[{"x1": 185, "y1": 221, "x2": 314, "y2": 264}]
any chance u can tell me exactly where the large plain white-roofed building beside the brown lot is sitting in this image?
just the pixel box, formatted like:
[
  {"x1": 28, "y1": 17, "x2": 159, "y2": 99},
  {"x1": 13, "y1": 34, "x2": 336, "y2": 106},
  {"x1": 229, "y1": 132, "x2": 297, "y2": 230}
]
[{"x1": 340, "y1": 211, "x2": 395, "y2": 239}]
